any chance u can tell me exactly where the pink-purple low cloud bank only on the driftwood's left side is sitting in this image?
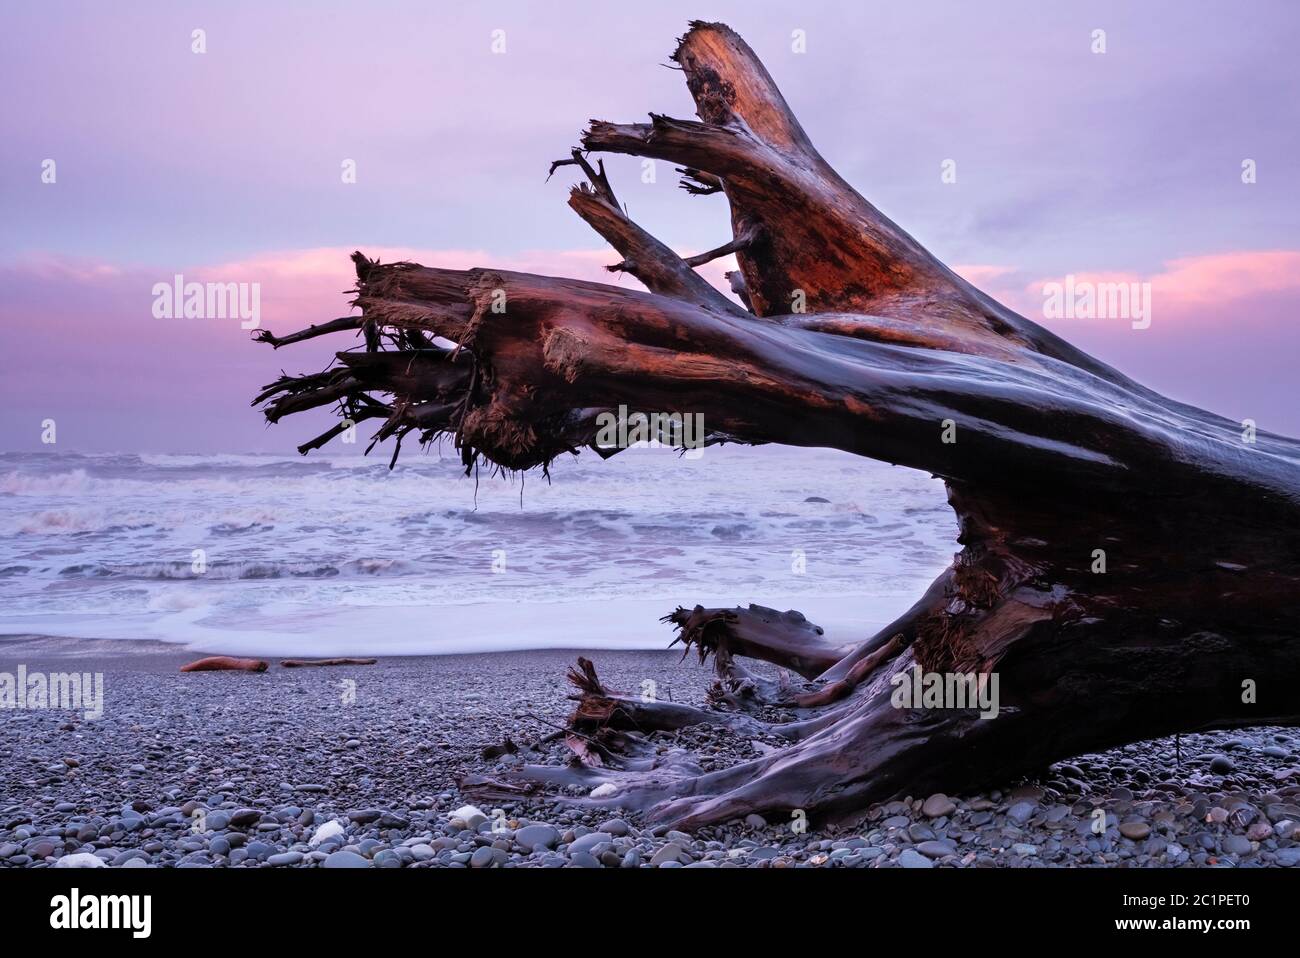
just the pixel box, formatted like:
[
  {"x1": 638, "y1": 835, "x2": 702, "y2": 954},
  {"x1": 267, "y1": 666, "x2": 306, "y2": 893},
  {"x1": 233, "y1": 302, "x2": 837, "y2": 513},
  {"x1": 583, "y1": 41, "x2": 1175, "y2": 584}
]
[{"x1": 0, "y1": 246, "x2": 748, "y2": 452}]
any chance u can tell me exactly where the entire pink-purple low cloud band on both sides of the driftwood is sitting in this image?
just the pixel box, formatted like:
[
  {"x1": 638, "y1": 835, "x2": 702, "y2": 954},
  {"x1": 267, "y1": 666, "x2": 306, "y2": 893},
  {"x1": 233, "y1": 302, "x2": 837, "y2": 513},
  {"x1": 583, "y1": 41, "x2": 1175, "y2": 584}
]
[{"x1": 0, "y1": 247, "x2": 1300, "y2": 451}]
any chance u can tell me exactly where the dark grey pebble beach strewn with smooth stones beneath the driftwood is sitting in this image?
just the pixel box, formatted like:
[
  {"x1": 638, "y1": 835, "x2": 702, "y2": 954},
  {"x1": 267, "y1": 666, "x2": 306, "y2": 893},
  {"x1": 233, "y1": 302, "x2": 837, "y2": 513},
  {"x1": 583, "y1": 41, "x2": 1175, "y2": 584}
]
[{"x1": 0, "y1": 637, "x2": 1300, "y2": 868}]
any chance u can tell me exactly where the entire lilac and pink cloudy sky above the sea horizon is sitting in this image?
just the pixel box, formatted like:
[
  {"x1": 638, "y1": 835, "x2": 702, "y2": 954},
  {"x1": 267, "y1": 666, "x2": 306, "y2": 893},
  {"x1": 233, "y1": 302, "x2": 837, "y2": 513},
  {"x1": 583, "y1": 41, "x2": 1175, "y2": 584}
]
[{"x1": 0, "y1": 0, "x2": 1300, "y2": 454}]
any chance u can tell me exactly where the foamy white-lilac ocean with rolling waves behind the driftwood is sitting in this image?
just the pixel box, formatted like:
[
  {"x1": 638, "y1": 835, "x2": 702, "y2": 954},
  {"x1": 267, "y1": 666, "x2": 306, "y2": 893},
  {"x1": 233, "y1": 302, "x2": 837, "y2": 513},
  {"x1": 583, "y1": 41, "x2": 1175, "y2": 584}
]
[{"x1": 0, "y1": 446, "x2": 958, "y2": 656}]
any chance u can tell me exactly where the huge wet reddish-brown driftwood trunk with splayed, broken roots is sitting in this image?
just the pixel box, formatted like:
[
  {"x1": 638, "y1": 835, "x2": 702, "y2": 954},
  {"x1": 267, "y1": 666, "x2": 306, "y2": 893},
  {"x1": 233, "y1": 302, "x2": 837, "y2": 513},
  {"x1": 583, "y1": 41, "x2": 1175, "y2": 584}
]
[{"x1": 255, "y1": 23, "x2": 1300, "y2": 828}]
